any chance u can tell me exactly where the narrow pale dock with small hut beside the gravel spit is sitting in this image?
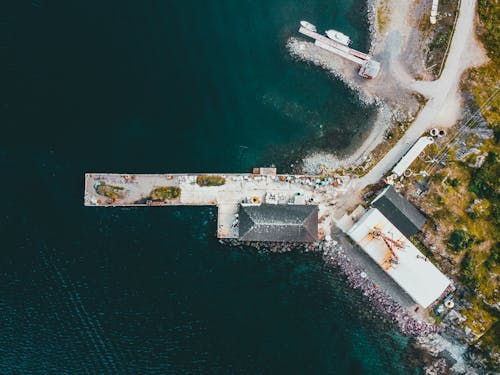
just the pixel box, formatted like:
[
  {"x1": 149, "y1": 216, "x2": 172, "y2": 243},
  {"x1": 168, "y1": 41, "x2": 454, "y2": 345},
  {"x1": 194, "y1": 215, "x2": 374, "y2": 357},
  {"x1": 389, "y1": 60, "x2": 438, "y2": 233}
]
[{"x1": 299, "y1": 21, "x2": 380, "y2": 79}]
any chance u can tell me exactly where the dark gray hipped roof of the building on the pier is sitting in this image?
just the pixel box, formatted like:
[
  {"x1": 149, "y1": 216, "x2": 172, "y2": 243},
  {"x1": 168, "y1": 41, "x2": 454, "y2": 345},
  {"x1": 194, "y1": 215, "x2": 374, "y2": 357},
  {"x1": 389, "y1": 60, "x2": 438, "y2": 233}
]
[{"x1": 239, "y1": 204, "x2": 318, "y2": 242}]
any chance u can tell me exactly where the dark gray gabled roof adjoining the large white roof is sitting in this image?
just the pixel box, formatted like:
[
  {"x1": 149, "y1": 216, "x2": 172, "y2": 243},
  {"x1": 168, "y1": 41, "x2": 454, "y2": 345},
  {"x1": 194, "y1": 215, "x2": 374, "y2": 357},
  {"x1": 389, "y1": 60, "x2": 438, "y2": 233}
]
[{"x1": 372, "y1": 185, "x2": 426, "y2": 237}]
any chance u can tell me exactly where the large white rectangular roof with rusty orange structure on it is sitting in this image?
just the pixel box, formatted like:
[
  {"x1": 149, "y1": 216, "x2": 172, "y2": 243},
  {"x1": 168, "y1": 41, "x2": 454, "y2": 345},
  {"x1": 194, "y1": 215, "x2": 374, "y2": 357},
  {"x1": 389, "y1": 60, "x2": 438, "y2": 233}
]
[{"x1": 348, "y1": 208, "x2": 450, "y2": 308}]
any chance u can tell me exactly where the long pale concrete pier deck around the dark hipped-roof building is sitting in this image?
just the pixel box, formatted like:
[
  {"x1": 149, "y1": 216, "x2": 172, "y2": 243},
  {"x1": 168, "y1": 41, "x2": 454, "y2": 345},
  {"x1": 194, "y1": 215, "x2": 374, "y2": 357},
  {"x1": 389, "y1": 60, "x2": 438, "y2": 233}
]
[{"x1": 84, "y1": 168, "x2": 345, "y2": 238}]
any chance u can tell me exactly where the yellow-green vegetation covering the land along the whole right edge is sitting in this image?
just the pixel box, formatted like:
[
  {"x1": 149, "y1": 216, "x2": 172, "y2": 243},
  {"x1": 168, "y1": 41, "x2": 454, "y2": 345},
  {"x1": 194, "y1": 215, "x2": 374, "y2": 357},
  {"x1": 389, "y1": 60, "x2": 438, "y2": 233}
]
[{"x1": 398, "y1": 0, "x2": 500, "y2": 369}]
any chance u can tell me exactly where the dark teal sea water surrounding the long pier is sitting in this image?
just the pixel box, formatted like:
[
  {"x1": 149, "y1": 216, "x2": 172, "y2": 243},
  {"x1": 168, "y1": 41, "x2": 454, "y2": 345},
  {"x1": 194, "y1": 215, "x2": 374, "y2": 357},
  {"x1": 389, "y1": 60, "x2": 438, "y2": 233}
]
[{"x1": 0, "y1": 0, "x2": 418, "y2": 374}]
